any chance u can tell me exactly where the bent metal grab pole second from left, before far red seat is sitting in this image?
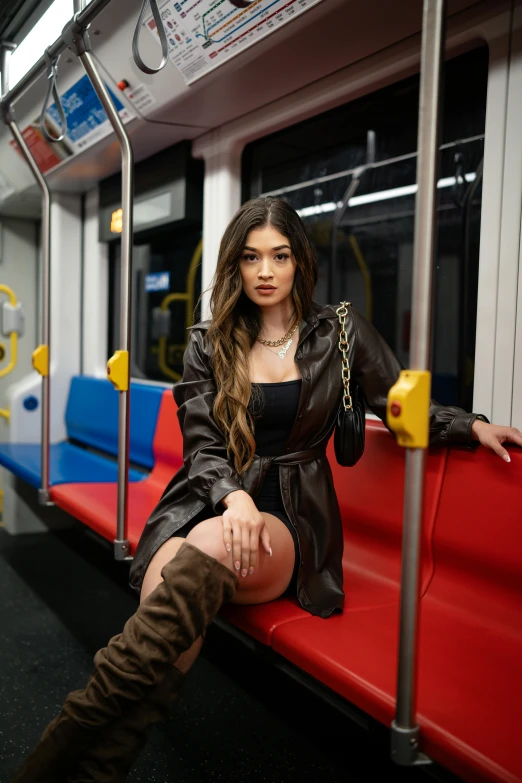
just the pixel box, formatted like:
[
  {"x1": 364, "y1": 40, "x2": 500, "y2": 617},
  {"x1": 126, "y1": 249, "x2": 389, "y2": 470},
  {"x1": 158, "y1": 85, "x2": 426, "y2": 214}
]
[{"x1": 62, "y1": 16, "x2": 134, "y2": 560}]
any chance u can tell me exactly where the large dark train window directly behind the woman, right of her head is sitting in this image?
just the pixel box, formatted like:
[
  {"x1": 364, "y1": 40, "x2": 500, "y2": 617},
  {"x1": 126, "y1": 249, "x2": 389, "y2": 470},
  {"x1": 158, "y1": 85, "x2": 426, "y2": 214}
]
[{"x1": 243, "y1": 47, "x2": 488, "y2": 410}]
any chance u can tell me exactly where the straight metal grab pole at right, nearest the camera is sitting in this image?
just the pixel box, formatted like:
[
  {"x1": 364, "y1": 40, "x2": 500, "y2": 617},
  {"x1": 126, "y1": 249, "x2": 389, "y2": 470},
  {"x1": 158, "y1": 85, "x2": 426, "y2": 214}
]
[{"x1": 388, "y1": 0, "x2": 445, "y2": 765}]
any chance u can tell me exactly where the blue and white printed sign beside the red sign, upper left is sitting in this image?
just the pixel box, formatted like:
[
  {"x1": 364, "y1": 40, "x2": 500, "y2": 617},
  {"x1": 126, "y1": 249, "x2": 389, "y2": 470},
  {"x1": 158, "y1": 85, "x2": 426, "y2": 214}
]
[{"x1": 47, "y1": 75, "x2": 136, "y2": 152}]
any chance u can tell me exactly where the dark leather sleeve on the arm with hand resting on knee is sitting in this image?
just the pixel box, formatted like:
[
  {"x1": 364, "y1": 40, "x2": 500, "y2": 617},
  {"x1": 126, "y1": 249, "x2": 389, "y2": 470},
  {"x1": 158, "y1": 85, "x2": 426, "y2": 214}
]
[{"x1": 173, "y1": 330, "x2": 243, "y2": 513}]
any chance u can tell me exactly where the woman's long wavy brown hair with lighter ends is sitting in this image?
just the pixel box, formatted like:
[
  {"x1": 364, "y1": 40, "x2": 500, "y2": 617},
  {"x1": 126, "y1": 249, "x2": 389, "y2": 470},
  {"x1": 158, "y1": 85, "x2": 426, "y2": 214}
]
[{"x1": 207, "y1": 196, "x2": 317, "y2": 474}]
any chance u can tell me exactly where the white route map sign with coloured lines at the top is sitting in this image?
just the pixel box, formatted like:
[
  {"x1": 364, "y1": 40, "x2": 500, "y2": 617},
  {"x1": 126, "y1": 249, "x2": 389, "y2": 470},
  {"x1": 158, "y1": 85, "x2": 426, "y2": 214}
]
[{"x1": 144, "y1": 0, "x2": 321, "y2": 84}]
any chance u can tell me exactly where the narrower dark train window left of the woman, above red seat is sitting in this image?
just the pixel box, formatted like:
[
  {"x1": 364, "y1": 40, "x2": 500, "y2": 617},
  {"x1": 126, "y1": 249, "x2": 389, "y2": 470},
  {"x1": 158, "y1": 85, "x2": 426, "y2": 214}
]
[{"x1": 104, "y1": 142, "x2": 203, "y2": 383}]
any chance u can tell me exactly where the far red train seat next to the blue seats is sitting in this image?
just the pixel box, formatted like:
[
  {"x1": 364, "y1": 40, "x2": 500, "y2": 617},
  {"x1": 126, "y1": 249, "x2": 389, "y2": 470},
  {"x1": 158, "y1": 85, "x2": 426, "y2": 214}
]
[{"x1": 51, "y1": 390, "x2": 183, "y2": 554}]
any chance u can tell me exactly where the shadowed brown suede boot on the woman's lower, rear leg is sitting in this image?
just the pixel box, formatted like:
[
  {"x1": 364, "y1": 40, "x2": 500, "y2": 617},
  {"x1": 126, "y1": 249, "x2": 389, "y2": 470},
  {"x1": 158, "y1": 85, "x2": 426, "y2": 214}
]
[{"x1": 67, "y1": 666, "x2": 186, "y2": 783}]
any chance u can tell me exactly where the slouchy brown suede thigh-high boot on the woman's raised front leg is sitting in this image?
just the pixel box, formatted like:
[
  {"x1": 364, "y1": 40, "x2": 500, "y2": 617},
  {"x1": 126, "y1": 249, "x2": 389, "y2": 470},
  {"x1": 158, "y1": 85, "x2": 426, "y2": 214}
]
[{"x1": 13, "y1": 542, "x2": 239, "y2": 783}]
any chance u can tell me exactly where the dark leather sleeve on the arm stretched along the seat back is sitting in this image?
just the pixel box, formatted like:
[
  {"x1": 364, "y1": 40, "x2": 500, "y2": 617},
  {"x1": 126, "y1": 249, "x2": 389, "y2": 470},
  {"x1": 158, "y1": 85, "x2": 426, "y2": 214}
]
[{"x1": 351, "y1": 308, "x2": 487, "y2": 445}]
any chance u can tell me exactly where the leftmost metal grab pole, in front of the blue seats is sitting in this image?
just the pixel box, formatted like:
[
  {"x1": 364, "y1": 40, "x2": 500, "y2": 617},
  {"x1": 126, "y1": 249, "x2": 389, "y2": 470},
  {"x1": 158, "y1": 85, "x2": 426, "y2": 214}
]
[{"x1": 1, "y1": 43, "x2": 53, "y2": 505}]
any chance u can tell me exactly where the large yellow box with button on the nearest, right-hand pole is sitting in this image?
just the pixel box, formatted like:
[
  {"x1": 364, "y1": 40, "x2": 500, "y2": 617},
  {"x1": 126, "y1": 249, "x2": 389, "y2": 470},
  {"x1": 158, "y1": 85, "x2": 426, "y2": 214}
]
[{"x1": 386, "y1": 370, "x2": 431, "y2": 449}]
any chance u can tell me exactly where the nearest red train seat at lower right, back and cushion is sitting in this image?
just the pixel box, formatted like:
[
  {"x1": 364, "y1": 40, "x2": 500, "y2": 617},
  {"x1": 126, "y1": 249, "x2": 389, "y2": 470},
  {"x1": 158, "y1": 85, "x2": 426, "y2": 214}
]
[{"x1": 272, "y1": 449, "x2": 522, "y2": 783}]
